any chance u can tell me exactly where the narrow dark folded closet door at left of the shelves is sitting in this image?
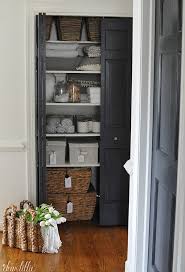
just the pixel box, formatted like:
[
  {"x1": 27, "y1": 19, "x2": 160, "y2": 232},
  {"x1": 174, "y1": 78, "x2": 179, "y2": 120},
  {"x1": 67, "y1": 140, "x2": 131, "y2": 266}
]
[{"x1": 36, "y1": 14, "x2": 46, "y2": 204}]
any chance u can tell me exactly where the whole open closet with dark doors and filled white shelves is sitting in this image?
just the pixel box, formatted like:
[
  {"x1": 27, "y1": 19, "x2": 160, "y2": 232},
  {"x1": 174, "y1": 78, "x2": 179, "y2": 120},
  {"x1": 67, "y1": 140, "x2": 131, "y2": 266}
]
[{"x1": 36, "y1": 14, "x2": 132, "y2": 225}]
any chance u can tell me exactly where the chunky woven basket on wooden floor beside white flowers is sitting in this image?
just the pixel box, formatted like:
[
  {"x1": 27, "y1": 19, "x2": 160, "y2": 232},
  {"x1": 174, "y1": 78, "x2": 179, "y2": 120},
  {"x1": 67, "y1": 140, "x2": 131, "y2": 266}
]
[{"x1": 2, "y1": 201, "x2": 43, "y2": 252}]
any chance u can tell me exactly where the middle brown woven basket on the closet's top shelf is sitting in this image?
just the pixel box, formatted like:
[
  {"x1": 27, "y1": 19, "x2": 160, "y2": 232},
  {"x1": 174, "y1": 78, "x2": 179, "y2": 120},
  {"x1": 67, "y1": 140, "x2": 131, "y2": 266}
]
[{"x1": 57, "y1": 16, "x2": 82, "y2": 41}]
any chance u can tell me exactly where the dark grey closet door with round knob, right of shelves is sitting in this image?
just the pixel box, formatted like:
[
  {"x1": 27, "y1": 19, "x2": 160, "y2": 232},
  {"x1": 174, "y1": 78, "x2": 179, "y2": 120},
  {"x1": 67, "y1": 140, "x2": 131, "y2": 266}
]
[{"x1": 100, "y1": 18, "x2": 132, "y2": 225}]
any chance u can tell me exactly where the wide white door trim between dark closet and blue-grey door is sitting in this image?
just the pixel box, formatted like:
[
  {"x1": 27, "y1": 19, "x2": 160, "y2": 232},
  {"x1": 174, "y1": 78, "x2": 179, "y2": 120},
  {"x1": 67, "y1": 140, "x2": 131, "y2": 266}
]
[{"x1": 127, "y1": 0, "x2": 155, "y2": 272}]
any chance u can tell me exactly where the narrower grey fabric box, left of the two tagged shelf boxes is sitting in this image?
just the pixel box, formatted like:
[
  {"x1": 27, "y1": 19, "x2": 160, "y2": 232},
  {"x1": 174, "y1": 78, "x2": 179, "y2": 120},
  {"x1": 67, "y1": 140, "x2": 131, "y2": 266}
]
[{"x1": 46, "y1": 140, "x2": 66, "y2": 165}]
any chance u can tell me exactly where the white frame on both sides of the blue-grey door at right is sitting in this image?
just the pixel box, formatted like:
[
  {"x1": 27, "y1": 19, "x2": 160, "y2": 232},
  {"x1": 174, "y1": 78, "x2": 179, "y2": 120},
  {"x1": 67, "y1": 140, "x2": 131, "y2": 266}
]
[{"x1": 129, "y1": 0, "x2": 185, "y2": 272}]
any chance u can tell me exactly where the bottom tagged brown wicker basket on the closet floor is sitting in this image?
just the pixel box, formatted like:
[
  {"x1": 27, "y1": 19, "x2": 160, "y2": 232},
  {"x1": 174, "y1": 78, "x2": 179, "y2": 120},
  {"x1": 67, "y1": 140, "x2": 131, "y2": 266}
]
[{"x1": 48, "y1": 186, "x2": 96, "y2": 221}]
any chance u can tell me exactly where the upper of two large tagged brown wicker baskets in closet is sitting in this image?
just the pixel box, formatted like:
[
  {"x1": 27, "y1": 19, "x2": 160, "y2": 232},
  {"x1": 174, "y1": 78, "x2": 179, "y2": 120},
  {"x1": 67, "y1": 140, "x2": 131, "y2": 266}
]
[{"x1": 47, "y1": 168, "x2": 92, "y2": 194}]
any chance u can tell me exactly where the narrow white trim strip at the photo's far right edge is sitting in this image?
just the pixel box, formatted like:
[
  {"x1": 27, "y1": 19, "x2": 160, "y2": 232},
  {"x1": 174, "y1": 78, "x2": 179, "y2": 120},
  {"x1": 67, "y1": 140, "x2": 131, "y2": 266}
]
[{"x1": 173, "y1": 1, "x2": 185, "y2": 272}]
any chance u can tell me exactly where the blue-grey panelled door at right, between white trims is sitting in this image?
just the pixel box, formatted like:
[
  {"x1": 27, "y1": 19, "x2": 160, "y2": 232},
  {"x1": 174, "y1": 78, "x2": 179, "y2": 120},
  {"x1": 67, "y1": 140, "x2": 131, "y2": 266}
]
[{"x1": 148, "y1": 0, "x2": 182, "y2": 272}]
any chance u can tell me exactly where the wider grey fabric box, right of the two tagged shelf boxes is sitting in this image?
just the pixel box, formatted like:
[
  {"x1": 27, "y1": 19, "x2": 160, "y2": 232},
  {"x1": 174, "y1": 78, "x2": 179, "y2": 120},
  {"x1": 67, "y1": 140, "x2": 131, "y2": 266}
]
[{"x1": 69, "y1": 140, "x2": 98, "y2": 164}]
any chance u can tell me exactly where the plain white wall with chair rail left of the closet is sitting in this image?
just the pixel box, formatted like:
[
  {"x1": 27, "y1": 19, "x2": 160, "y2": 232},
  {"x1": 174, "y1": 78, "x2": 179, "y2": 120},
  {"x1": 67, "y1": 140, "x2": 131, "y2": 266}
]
[{"x1": 0, "y1": 0, "x2": 27, "y2": 226}]
